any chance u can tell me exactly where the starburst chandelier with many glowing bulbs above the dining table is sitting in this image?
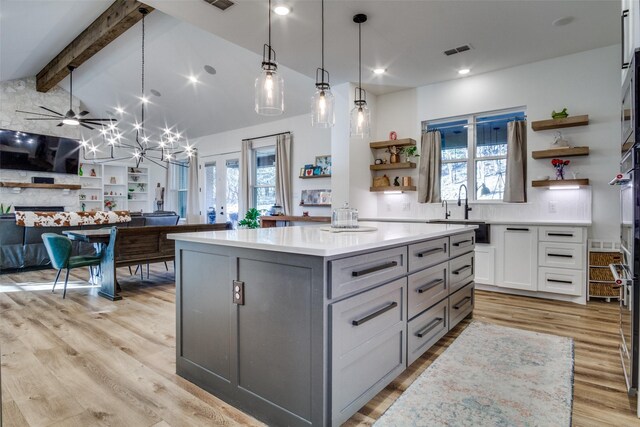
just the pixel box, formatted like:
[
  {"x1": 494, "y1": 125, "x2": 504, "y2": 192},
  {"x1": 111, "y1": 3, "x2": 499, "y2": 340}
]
[{"x1": 80, "y1": 8, "x2": 196, "y2": 169}]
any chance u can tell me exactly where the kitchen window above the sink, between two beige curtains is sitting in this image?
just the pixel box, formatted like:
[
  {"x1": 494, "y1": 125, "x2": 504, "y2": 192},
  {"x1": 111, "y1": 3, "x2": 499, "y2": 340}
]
[{"x1": 423, "y1": 110, "x2": 525, "y2": 204}]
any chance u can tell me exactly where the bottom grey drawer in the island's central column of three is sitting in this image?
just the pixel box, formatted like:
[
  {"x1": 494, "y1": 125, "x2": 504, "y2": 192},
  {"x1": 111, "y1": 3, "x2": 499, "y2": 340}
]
[{"x1": 407, "y1": 299, "x2": 449, "y2": 366}]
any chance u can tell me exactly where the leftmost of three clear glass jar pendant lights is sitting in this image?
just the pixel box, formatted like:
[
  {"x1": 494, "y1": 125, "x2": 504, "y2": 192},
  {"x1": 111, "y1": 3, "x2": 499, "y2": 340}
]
[{"x1": 255, "y1": 0, "x2": 284, "y2": 116}]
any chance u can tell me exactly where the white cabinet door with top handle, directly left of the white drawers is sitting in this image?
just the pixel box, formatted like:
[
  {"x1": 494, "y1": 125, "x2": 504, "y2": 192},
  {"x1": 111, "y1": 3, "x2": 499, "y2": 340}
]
[{"x1": 494, "y1": 225, "x2": 538, "y2": 291}]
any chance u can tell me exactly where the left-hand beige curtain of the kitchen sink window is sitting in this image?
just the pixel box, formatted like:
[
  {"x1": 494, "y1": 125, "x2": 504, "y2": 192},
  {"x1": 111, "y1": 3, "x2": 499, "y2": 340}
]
[{"x1": 418, "y1": 130, "x2": 442, "y2": 203}]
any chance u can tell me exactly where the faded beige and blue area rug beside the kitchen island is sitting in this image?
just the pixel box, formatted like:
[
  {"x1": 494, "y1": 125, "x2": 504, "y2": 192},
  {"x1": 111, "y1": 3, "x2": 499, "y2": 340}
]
[{"x1": 374, "y1": 321, "x2": 574, "y2": 427}]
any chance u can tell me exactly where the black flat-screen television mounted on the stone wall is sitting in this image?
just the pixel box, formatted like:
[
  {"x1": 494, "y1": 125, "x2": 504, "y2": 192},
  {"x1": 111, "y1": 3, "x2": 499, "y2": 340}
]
[{"x1": 0, "y1": 129, "x2": 80, "y2": 175}]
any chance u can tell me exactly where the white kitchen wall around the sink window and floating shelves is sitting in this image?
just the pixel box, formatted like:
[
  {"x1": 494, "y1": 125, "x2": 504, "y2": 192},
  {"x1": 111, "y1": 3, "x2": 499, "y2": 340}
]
[{"x1": 374, "y1": 45, "x2": 620, "y2": 244}]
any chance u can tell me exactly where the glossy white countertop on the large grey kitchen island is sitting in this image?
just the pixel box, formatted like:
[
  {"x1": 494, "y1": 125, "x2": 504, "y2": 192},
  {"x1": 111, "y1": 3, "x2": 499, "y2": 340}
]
[{"x1": 167, "y1": 222, "x2": 477, "y2": 256}]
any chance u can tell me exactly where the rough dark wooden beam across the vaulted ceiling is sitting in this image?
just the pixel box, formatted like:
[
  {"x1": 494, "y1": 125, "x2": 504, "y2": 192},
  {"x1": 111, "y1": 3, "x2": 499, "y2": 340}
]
[{"x1": 36, "y1": 0, "x2": 153, "y2": 92}]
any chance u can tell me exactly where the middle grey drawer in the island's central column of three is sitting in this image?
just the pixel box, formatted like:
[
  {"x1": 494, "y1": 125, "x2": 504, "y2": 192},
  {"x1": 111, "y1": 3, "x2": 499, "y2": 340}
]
[{"x1": 407, "y1": 262, "x2": 449, "y2": 319}]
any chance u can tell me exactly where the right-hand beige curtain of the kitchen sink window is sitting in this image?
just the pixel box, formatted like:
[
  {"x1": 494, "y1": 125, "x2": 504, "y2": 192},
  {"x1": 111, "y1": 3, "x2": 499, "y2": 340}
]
[{"x1": 502, "y1": 121, "x2": 527, "y2": 203}]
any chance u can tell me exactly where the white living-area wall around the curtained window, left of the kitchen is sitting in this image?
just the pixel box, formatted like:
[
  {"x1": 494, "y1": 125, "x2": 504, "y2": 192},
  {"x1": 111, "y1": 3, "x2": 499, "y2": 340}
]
[{"x1": 192, "y1": 114, "x2": 335, "y2": 216}]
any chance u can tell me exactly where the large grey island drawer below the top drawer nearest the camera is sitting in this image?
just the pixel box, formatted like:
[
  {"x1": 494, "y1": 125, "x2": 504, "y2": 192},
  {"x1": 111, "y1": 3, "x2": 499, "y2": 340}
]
[{"x1": 330, "y1": 277, "x2": 407, "y2": 357}]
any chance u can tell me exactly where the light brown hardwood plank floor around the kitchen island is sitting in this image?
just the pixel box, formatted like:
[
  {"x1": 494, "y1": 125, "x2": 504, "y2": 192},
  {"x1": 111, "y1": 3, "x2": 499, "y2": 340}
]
[{"x1": 0, "y1": 270, "x2": 640, "y2": 427}]
